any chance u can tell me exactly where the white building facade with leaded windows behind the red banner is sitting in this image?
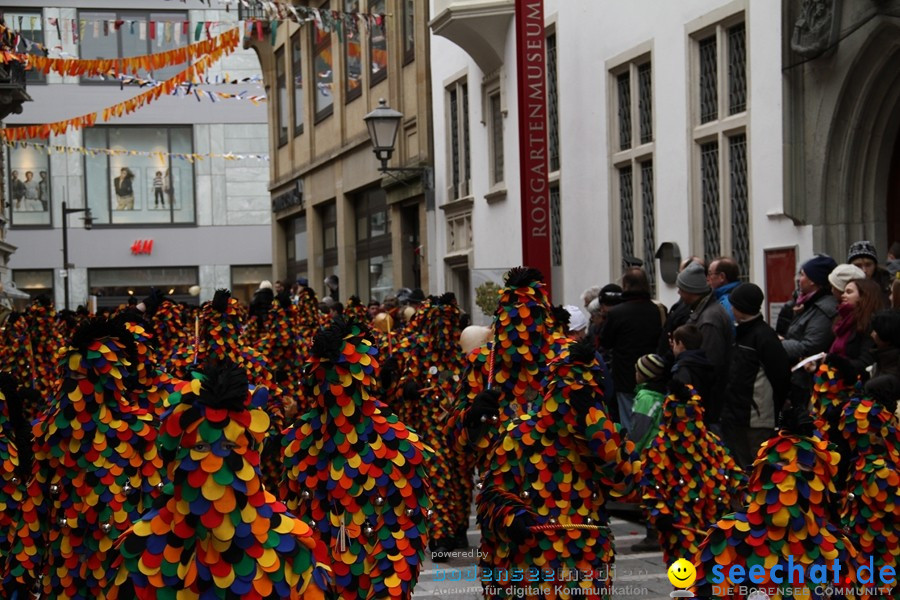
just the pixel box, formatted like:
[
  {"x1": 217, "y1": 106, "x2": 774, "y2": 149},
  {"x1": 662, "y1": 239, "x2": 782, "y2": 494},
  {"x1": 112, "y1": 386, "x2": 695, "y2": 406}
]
[{"x1": 431, "y1": 0, "x2": 821, "y2": 321}]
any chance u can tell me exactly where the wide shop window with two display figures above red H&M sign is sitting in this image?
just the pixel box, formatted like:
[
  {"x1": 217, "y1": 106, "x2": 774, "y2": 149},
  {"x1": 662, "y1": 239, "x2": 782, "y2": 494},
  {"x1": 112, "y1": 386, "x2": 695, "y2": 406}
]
[{"x1": 84, "y1": 126, "x2": 195, "y2": 225}]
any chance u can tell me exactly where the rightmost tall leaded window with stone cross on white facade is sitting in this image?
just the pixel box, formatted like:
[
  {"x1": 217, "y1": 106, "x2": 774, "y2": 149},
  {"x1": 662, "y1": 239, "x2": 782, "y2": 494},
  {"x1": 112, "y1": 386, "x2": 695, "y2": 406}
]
[{"x1": 692, "y1": 15, "x2": 750, "y2": 275}]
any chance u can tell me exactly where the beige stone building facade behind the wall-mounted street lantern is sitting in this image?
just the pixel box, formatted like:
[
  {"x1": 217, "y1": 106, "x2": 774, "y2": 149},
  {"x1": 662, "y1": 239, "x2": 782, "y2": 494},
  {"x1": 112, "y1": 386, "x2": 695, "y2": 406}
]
[{"x1": 246, "y1": 0, "x2": 435, "y2": 302}]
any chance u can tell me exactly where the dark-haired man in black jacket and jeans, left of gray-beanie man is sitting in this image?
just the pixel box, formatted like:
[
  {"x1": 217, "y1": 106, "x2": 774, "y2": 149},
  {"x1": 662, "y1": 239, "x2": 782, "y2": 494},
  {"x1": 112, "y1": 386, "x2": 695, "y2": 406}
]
[{"x1": 600, "y1": 267, "x2": 662, "y2": 429}]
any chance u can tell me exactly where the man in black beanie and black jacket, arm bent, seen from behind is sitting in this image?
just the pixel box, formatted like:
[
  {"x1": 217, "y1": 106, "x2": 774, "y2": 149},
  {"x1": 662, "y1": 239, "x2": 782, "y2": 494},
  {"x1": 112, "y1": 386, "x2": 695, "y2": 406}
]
[{"x1": 722, "y1": 283, "x2": 791, "y2": 469}]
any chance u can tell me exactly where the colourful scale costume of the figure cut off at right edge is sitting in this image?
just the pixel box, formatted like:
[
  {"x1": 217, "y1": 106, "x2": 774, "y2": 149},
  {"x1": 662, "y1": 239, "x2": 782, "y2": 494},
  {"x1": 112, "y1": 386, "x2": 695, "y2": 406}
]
[{"x1": 839, "y1": 398, "x2": 900, "y2": 592}]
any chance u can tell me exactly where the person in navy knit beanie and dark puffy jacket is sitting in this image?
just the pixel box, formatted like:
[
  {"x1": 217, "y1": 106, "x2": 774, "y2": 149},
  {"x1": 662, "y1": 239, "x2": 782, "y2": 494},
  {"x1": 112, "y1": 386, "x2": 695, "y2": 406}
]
[{"x1": 781, "y1": 254, "x2": 838, "y2": 404}]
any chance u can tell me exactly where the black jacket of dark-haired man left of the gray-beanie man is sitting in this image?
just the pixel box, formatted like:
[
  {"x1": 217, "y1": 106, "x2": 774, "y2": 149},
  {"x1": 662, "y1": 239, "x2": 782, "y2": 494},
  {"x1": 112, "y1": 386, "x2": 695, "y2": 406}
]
[{"x1": 600, "y1": 292, "x2": 662, "y2": 394}]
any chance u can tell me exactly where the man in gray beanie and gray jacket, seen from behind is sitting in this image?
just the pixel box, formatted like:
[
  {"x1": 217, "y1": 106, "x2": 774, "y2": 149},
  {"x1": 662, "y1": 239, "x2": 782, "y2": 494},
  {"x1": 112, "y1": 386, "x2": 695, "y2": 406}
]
[{"x1": 675, "y1": 263, "x2": 734, "y2": 426}]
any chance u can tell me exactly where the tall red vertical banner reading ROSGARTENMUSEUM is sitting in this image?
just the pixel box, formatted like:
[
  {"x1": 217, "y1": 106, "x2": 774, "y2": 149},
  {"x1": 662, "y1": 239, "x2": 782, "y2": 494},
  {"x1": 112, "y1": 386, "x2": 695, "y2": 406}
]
[{"x1": 516, "y1": 0, "x2": 551, "y2": 294}]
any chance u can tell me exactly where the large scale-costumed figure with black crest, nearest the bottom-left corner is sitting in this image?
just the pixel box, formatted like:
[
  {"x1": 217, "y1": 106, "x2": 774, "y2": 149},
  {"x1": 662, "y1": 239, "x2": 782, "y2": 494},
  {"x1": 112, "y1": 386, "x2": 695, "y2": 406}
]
[{"x1": 4, "y1": 319, "x2": 162, "y2": 600}]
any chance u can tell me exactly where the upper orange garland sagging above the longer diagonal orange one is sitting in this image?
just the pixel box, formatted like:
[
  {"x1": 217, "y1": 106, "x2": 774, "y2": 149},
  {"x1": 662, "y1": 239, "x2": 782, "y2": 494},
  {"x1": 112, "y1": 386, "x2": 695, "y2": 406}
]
[{"x1": 0, "y1": 26, "x2": 241, "y2": 77}]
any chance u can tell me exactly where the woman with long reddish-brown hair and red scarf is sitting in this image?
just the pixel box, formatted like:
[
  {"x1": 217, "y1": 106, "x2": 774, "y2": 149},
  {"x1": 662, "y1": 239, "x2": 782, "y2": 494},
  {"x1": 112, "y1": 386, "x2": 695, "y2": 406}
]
[{"x1": 829, "y1": 279, "x2": 884, "y2": 373}]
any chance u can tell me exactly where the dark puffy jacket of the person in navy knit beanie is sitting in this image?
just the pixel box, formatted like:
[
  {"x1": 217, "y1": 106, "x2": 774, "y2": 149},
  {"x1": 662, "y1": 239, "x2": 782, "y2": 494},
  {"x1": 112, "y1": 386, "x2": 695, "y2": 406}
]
[{"x1": 781, "y1": 290, "x2": 837, "y2": 399}]
